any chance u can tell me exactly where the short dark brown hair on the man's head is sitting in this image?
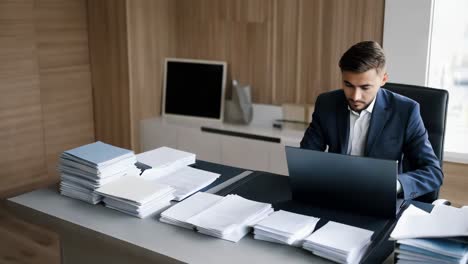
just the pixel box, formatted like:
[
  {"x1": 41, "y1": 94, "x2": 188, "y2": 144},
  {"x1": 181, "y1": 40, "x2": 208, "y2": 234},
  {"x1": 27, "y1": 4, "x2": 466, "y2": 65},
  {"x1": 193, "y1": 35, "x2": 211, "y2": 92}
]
[{"x1": 339, "y1": 41, "x2": 385, "y2": 73}]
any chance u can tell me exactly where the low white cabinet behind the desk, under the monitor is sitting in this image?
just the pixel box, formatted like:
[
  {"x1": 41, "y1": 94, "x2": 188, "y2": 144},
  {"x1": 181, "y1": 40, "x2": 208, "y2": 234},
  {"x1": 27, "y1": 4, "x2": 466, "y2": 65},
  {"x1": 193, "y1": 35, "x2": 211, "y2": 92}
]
[{"x1": 141, "y1": 118, "x2": 303, "y2": 175}]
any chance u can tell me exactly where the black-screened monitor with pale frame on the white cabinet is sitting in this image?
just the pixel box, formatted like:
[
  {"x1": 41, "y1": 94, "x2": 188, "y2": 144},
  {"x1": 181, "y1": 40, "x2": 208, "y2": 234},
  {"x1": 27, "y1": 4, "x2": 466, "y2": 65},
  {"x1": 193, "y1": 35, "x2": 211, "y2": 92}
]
[{"x1": 163, "y1": 59, "x2": 226, "y2": 120}]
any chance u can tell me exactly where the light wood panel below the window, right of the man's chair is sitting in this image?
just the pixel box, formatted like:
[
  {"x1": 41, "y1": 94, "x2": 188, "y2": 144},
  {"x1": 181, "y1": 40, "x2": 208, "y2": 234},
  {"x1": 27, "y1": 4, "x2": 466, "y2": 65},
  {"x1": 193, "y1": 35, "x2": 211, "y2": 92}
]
[{"x1": 439, "y1": 162, "x2": 468, "y2": 206}]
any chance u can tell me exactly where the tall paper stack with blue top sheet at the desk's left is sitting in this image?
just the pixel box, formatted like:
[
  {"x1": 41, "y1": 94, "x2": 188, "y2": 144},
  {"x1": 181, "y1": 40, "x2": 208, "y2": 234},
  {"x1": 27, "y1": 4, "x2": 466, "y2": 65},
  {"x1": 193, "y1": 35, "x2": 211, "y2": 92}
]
[{"x1": 58, "y1": 141, "x2": 140, "y2": 204}]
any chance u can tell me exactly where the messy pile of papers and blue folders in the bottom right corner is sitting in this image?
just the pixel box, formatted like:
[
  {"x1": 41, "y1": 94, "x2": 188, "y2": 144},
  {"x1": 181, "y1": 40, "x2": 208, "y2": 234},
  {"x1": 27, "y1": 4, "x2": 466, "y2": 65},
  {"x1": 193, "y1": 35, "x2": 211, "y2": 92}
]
[{"x1": 390, "y1": 205, "x2": 468, "y2": 264}]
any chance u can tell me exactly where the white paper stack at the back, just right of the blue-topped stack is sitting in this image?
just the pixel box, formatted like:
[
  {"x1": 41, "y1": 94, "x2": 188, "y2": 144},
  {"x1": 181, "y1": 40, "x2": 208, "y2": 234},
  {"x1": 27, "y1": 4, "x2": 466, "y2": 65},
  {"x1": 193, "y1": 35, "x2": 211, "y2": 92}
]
[{"x1": 136, "y1": 147, "x2": 196, "y2": 178}]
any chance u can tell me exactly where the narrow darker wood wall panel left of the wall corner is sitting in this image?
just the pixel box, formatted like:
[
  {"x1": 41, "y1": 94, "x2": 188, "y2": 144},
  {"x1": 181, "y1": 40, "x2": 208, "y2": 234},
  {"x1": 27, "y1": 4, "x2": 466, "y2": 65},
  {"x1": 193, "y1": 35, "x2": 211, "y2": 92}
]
[{"x1": 88, "y1": 0, "x2": 131, "y2": 148}]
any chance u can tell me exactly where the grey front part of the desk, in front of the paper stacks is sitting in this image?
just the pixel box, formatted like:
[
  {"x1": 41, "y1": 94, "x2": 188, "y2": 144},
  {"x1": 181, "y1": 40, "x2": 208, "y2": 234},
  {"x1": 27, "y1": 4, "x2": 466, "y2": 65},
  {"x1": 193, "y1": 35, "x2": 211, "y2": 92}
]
[{"x1": 9, "y1": 162, "x2": 394, "y2": 264}]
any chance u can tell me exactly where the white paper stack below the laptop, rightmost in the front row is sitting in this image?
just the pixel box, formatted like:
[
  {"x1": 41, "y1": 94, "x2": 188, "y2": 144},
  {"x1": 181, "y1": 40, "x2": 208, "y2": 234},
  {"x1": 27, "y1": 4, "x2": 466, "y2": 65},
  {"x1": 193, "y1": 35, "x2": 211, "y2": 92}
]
[{"x1": 303, "y1": 221, "x2": 373, "y2": 263}]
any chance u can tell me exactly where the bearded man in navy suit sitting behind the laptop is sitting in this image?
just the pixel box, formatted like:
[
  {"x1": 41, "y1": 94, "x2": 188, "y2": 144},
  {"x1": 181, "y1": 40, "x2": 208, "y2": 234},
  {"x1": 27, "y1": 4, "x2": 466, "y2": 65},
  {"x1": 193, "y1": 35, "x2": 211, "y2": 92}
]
[{"x1": 301, "y1": 41, "x2": 443, "y2": 199}]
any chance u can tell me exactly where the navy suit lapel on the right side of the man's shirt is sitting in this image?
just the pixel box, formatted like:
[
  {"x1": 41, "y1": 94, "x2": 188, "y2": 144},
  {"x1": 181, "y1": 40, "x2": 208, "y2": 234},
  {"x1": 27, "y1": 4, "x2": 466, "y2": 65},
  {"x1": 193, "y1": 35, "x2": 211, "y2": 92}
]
[{"x1": 364, "y1": 88, "x2": 390, "y2": 156}]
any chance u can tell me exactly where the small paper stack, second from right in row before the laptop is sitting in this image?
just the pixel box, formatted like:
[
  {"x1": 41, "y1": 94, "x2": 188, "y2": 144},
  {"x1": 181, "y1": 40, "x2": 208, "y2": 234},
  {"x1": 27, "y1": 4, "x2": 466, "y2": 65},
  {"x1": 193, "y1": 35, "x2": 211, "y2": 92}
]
[{"x1": 254, "y1": 210, "x2": 320, "y2": 246}]
